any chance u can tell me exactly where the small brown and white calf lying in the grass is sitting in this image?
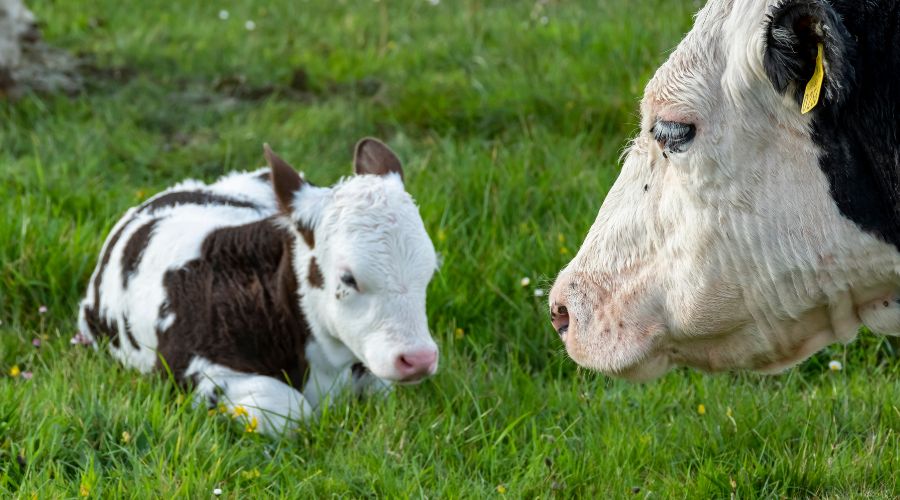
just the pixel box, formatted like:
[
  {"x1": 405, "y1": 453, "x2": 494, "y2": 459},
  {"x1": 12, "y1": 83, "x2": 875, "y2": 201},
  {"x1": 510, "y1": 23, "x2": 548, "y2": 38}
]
[{"x1": 78, "y1": 138, "x2": 438, "y2": 436}]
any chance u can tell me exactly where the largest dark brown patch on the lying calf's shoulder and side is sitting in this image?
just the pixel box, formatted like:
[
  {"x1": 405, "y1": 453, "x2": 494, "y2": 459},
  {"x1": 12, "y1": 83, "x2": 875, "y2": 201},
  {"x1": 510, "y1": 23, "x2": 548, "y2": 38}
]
[{"x1": 157, "y1": 218, "x2": 310, "y2": 387}]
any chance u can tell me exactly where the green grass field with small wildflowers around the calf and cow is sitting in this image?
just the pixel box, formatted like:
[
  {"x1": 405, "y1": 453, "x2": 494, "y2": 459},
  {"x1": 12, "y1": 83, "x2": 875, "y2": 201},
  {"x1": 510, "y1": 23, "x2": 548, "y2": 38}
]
[{"x1": 0, "y1": 0, "x2": 900, "y2": 498}]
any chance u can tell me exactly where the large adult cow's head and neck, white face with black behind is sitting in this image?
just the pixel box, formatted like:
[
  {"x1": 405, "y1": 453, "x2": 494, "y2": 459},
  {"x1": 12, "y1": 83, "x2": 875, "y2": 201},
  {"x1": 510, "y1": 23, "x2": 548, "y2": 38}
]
[{"x1": 550, "y1": 0, "x2": 900, "y2": 379}]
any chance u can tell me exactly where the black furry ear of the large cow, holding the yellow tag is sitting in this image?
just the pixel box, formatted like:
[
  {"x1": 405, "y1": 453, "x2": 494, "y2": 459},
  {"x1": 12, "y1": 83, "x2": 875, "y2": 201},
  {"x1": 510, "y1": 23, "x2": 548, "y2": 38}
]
[{"x1": 763, "y1": 0, "x2": 856, "y2": 110}]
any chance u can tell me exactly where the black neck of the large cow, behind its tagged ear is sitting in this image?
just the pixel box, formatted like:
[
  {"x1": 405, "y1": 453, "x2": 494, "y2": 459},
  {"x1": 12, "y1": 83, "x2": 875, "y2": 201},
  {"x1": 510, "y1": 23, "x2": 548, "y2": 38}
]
[{"x1": 813, "y1": 0, "x2": 900, "y2": 250}]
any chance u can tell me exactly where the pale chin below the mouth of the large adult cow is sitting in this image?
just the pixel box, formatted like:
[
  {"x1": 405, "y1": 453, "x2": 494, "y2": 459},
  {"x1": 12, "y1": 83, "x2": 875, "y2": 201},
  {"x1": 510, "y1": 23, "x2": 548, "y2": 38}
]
[{"x1": 563, "y1": 322, "x2": 671, "y2": 382}]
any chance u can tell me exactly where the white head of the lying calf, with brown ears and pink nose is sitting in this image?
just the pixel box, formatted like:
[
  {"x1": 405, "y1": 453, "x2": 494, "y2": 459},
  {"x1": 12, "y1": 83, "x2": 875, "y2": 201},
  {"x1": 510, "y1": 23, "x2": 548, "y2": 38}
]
[{"x1": 266, "y1": 139, "x2": 438, "y2": 382}]
